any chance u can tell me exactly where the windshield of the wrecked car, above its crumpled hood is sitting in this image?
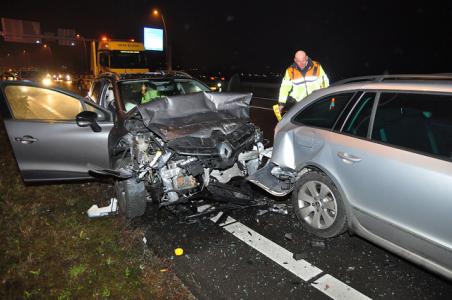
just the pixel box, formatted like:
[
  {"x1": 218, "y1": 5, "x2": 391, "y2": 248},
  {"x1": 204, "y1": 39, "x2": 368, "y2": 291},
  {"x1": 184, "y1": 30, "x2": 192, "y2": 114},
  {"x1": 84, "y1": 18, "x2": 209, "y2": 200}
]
[{"x1": 119, "y1": 78, "x2": 210, "y2": 111}]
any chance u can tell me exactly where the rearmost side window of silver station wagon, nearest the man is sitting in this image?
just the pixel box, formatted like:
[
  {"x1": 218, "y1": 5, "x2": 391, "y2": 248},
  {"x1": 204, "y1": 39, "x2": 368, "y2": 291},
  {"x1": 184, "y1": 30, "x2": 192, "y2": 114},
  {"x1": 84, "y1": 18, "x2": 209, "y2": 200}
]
[{"x1": 293, "y1": 93, "x2": 354, "y2": 129}]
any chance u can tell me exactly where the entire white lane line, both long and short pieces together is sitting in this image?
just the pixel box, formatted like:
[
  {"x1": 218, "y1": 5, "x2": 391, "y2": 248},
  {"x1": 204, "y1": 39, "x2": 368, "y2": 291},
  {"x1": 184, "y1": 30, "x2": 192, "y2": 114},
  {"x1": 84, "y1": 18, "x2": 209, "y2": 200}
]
[{"x1": 208, "y1": 214, "x2": 371, "y2": 300}]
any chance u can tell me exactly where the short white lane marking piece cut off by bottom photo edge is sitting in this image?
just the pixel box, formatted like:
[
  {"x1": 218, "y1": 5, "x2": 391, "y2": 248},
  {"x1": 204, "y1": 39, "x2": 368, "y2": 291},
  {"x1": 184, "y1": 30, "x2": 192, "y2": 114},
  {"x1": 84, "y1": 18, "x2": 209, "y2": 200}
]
[{"x1": 311, "y1": 274, "x2": 370, "y2": 300}]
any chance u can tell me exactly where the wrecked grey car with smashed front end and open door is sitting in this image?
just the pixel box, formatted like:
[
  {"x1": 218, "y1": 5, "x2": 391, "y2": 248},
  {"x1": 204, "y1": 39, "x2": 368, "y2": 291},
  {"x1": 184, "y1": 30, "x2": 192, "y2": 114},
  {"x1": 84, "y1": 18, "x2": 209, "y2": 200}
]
[{"x1": 0, "y1": 74, "x2": 263, "y2": 218}]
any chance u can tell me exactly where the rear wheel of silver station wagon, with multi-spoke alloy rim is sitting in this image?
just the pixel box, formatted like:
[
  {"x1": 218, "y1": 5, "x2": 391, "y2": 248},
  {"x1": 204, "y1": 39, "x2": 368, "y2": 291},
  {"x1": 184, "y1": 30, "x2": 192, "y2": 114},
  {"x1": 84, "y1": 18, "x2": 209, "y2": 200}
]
[{"x1": 292, "y1": 171, "x2": 347, "y2": 238}]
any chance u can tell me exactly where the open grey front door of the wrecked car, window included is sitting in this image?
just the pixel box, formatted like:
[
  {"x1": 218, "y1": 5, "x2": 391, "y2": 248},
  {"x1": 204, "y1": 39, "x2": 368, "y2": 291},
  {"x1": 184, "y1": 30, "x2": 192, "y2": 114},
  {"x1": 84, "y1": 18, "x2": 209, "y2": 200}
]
[{"x1": 0, "y1": 82, "x2": 113, "y2": 182}]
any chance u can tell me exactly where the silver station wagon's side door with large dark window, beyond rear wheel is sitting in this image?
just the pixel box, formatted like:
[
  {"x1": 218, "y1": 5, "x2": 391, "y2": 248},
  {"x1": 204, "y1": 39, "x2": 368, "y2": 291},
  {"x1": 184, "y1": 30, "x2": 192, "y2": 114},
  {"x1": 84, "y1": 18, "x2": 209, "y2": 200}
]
[{"x1": 331, "y1": 92, "x2": 452, "y2": 268}]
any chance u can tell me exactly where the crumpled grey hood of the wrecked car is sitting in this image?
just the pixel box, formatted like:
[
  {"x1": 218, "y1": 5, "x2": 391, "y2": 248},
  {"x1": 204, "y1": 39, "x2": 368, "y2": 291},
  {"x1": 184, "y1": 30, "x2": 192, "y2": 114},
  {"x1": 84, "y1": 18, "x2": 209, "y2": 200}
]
[{"x1": 137, "y1": 92, "x2": 252, "y2": 140}]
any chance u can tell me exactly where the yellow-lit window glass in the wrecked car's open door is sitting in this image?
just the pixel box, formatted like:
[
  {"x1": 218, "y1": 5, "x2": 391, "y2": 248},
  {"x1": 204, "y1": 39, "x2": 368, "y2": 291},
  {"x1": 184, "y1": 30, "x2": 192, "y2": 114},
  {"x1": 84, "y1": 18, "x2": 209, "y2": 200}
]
[{"x1": 5, "y1": 85, "x2": 82, "y2": 121}]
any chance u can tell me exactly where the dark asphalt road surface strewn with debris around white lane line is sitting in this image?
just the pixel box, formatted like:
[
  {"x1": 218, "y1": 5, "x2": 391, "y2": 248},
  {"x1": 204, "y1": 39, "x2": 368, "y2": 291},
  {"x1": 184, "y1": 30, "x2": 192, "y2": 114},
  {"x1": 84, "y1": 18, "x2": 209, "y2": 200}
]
[{"x1": 141, "y1": 99, "x2": 452, "y2": 299}]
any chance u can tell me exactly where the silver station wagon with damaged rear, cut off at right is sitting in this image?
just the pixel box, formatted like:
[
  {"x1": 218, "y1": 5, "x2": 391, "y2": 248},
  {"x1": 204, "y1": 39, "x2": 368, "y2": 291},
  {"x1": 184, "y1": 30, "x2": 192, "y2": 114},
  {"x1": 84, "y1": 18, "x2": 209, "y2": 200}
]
[{"x1": 248, "y1": 75, "x2": 452, "y2": 279}]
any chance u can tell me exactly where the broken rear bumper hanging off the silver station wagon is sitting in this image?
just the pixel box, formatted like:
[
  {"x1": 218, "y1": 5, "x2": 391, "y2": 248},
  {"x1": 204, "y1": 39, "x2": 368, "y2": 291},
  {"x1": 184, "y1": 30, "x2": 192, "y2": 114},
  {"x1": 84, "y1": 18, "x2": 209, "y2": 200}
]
[{"x1": 246, "y1": 163, "x2": 296, "y2": 197}]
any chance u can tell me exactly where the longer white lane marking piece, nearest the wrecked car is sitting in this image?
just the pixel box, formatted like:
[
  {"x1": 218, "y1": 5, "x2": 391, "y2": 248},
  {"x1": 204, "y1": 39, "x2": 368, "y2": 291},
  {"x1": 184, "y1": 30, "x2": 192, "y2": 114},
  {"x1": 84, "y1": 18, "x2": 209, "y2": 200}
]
[{"x1": 215, "y1": 217, "x2": 322, "y2": 281}]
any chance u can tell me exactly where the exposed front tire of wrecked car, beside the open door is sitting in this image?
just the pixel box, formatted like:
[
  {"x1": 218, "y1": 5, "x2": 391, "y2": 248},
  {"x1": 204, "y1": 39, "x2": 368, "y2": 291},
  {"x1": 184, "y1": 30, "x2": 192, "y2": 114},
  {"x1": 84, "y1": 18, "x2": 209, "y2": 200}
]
[{"x1": 115, "y1": 158, "x2": 146, "y2": 219}]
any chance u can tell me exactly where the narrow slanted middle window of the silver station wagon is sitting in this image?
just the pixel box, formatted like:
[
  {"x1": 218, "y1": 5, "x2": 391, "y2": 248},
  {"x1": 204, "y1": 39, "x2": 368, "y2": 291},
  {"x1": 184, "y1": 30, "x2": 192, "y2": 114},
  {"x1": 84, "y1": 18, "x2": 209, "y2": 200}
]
[{"x1": 342, "y1": 93, "x2": 376, "y2": 137}]
